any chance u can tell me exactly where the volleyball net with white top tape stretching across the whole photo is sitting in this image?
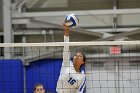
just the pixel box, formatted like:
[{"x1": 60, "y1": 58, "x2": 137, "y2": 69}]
[{"x1": 0, "y1": 41, "x2": 140, "y2": 93}]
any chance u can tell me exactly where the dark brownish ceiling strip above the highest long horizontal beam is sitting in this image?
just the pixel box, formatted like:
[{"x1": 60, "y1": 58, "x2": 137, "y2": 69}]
[{"x1": 26, "y1": 0, "x2": 140, "y2": 11}]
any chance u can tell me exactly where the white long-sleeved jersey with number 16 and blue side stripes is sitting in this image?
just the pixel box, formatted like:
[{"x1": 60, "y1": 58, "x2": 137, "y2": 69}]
[{"x1": 56, "y1": 36, "x2": 86, "y2": 93}]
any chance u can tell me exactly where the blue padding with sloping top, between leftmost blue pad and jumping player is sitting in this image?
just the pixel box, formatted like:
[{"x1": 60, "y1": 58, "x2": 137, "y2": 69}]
[{"x1": 26, "y1": 59, "x2": 62, "y2": 93}]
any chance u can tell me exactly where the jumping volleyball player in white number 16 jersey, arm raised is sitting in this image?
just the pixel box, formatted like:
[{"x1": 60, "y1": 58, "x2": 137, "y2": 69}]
[{"x1": 56, "y1": 24, "x2": 86, "y2": 93}]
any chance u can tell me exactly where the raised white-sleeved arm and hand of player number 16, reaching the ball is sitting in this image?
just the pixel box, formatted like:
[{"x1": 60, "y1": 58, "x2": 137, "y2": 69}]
[{"x1": 63, "y1": 24, "x2": 70, "y2": 66}]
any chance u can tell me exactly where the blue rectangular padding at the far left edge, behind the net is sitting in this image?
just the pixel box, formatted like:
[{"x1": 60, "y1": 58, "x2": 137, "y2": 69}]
[{"x1": 0, "y1": 60, "x2": 24, "y2": 93}]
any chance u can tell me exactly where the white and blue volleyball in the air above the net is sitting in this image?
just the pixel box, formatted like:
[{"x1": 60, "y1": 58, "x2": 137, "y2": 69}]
[{"x1": 64, "y1": 14, "x2": 79, "y2": 28}]
